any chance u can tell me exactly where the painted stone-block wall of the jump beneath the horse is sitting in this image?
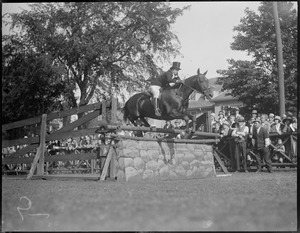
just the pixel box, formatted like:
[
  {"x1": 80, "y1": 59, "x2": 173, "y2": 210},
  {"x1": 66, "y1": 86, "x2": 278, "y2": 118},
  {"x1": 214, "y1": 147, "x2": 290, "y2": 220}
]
[{"x1": 116, "y1": 140, "x2": 216, "y2": 181}]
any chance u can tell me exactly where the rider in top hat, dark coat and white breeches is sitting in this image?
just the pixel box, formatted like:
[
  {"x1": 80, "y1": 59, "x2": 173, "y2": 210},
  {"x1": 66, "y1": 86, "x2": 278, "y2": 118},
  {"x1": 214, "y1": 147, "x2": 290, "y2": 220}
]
[{"x1": 150, "y1": 62, "x2": 181, "y2": 117}]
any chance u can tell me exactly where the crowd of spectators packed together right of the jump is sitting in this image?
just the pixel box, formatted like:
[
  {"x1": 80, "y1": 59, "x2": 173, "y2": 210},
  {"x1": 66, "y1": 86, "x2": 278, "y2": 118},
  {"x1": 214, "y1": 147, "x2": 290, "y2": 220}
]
[{"x1": 211, "y1": 109, "x2": 297, "y2": 172}]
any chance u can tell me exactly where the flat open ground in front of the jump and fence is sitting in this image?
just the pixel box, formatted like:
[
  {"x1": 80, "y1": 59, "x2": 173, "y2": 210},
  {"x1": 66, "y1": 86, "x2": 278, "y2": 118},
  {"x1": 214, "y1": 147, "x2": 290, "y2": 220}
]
[{"x1": 2, "y1": 171, "x2": 298, "y2": 231}]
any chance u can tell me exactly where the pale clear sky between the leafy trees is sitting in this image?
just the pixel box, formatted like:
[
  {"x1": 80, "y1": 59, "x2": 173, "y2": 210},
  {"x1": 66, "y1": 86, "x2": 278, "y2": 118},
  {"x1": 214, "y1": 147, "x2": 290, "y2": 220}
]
[{"x1": 2, "y1": 1, "x2": 260, "y2": 78}]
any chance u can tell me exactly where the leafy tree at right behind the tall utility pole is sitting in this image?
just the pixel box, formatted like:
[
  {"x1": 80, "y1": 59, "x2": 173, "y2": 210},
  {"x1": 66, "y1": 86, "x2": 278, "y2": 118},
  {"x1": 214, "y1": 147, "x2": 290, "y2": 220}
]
[{"x1": 218, "y1": 2, "x2": 298, "y2": 114}]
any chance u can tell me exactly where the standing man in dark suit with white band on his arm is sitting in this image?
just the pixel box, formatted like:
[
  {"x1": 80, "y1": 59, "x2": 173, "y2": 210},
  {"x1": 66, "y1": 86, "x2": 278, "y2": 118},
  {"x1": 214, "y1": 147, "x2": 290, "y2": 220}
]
[{"x1": 252, "y1": 118, "x2": 272, "y2": 173}]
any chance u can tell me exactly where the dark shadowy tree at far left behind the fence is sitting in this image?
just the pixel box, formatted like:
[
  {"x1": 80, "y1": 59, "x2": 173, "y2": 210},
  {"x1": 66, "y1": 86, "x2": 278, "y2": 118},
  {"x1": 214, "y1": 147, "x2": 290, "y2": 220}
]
[{"x1": 2, "y1": 36, "x2": 65, "y2": 138}]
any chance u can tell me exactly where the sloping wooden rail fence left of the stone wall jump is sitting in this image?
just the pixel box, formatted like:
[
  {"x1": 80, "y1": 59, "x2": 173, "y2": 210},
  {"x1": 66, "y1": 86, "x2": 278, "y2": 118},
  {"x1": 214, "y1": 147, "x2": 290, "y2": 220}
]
[{"x1": 2, "y1": 99, "x2": 117, "y2": 178}]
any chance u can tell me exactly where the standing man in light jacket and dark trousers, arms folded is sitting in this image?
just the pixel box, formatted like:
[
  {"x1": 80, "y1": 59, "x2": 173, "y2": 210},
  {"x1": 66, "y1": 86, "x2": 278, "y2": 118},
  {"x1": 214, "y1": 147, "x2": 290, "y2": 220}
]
[{"x1": 231, "y1": 116, "x2": 249, "y2": 172}]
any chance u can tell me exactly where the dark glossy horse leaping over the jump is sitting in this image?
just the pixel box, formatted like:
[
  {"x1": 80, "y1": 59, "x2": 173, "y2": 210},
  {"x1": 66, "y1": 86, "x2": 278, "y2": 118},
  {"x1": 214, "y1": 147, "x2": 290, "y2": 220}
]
[{"x1": 123, "y1": 69, "x2": 212, "y2": 129}]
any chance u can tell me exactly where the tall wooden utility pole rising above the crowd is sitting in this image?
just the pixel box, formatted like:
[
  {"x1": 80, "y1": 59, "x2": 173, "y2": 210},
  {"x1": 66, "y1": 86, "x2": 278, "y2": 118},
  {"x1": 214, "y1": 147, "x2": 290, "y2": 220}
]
[{"x1": 273, "y1": 2, "x2": 285, "y2": 117}]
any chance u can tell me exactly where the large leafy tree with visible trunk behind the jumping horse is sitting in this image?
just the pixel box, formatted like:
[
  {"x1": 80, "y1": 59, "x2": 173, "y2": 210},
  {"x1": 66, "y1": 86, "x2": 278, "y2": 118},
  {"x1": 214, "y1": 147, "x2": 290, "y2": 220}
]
[{"x1": 7, "y1": 2, "x2": 187, "y2": 111}]
